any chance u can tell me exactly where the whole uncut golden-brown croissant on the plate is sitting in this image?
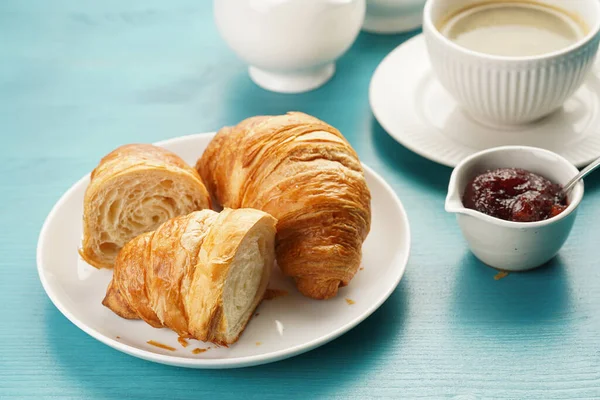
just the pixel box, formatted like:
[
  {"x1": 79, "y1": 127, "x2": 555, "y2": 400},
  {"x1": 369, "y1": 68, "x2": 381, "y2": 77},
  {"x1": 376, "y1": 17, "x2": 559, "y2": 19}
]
[{"x1": 196, "y1": 112, "x2": 371, "y2": 299}]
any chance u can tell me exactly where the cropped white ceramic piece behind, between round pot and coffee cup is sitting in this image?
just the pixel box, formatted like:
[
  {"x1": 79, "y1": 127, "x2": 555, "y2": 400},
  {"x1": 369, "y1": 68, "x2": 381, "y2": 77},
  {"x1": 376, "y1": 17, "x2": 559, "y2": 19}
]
[{"x1": 363, "y1": 0, "x2": 426, "y2": 34}]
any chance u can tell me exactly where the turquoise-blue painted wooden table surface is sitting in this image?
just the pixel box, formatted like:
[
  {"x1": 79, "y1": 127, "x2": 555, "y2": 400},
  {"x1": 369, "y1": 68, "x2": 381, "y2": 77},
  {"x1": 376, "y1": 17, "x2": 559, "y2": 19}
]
[{"x1": 0, "y1": 0, "x2": 600, "y2": 399}]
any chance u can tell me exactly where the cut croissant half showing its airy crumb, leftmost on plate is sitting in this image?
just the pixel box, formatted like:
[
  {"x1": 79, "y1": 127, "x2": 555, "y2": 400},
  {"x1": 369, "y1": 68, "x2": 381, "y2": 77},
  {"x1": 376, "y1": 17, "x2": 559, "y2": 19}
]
[{"x1": 79, "y1": 144, "x2": 211, "y2": 268}]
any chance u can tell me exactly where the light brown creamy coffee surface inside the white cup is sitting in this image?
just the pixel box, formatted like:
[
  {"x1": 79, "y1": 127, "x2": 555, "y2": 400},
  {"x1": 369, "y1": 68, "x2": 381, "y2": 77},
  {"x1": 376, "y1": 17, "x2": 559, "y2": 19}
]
[{"x1": 438, "y1": 0, "x2": 588, "y2": 57}]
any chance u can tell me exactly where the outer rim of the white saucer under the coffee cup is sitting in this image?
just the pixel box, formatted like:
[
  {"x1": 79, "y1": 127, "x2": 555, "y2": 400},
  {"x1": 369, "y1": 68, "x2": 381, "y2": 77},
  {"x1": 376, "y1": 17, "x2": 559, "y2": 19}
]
[{"x1": 369, "y1": 33, "x2": 597, "y2": 168}]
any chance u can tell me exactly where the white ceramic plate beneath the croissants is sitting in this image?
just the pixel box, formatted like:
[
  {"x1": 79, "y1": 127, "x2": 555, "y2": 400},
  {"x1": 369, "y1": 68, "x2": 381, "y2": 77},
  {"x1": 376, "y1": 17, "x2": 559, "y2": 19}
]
[{"x1": 37, "y1": 133, "x2": 410, "y2": 368}]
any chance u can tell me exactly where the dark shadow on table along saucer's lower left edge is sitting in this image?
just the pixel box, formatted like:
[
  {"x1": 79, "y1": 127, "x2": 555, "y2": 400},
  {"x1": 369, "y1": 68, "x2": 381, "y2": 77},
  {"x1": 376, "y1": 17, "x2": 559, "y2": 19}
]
[{"x1": 371, "y1": 117, "x2": 452, "y2": 193}]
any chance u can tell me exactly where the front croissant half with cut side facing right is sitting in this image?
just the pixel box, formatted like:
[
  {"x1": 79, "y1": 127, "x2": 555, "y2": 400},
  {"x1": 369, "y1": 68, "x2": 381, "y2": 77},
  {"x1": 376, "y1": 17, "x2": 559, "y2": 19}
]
[{"x1": 102, "y1": 209, "x2": 277, "y2": 345}]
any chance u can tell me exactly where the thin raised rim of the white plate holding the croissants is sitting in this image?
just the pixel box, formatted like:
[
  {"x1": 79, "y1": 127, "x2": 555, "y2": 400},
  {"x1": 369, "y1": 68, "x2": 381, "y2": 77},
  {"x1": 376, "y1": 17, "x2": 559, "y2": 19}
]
[{"x1": 36, "y1": 132, "x2": 411, "y2": 369}]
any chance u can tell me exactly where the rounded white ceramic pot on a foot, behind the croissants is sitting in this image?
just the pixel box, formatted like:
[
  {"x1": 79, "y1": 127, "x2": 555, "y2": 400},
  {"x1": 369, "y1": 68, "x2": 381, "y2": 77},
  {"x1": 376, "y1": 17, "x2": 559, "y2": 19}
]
[{"x1": 214, "y1": 0, "x2": 366, "y2": 93}]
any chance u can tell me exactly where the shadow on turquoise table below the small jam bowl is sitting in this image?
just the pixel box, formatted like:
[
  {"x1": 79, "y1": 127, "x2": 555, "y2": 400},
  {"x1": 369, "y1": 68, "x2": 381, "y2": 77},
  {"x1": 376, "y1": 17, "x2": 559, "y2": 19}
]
[{"x1": 453, "y1": 252, "x2": 571, "y2": 330}]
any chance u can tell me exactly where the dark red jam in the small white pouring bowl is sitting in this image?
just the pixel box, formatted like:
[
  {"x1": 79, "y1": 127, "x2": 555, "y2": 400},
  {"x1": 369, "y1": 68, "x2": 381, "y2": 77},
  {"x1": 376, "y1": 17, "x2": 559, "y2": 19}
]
[{"x1": 463, "y1": 168, "x2": 567, "y2": 222}]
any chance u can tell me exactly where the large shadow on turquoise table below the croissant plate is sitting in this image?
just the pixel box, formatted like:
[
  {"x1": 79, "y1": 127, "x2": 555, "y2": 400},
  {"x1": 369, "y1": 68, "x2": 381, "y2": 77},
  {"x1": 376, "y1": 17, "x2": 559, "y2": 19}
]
[{"x1": 45, "y1": 285, "x2": 407, "y2": 398}]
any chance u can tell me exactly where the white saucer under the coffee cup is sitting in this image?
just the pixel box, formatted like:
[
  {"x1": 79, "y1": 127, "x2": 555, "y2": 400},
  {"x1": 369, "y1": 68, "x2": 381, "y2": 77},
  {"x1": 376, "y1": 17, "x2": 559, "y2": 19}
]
[{"x1": 369, "y1": 34, "x2": 600, "y2": 167}]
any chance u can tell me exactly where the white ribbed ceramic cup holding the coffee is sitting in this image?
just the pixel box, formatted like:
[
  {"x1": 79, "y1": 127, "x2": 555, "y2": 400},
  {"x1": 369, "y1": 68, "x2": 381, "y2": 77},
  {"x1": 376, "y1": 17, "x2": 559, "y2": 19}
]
[{"x1": 423, "y1": 0, "x2": 600, "y2": 125}]
